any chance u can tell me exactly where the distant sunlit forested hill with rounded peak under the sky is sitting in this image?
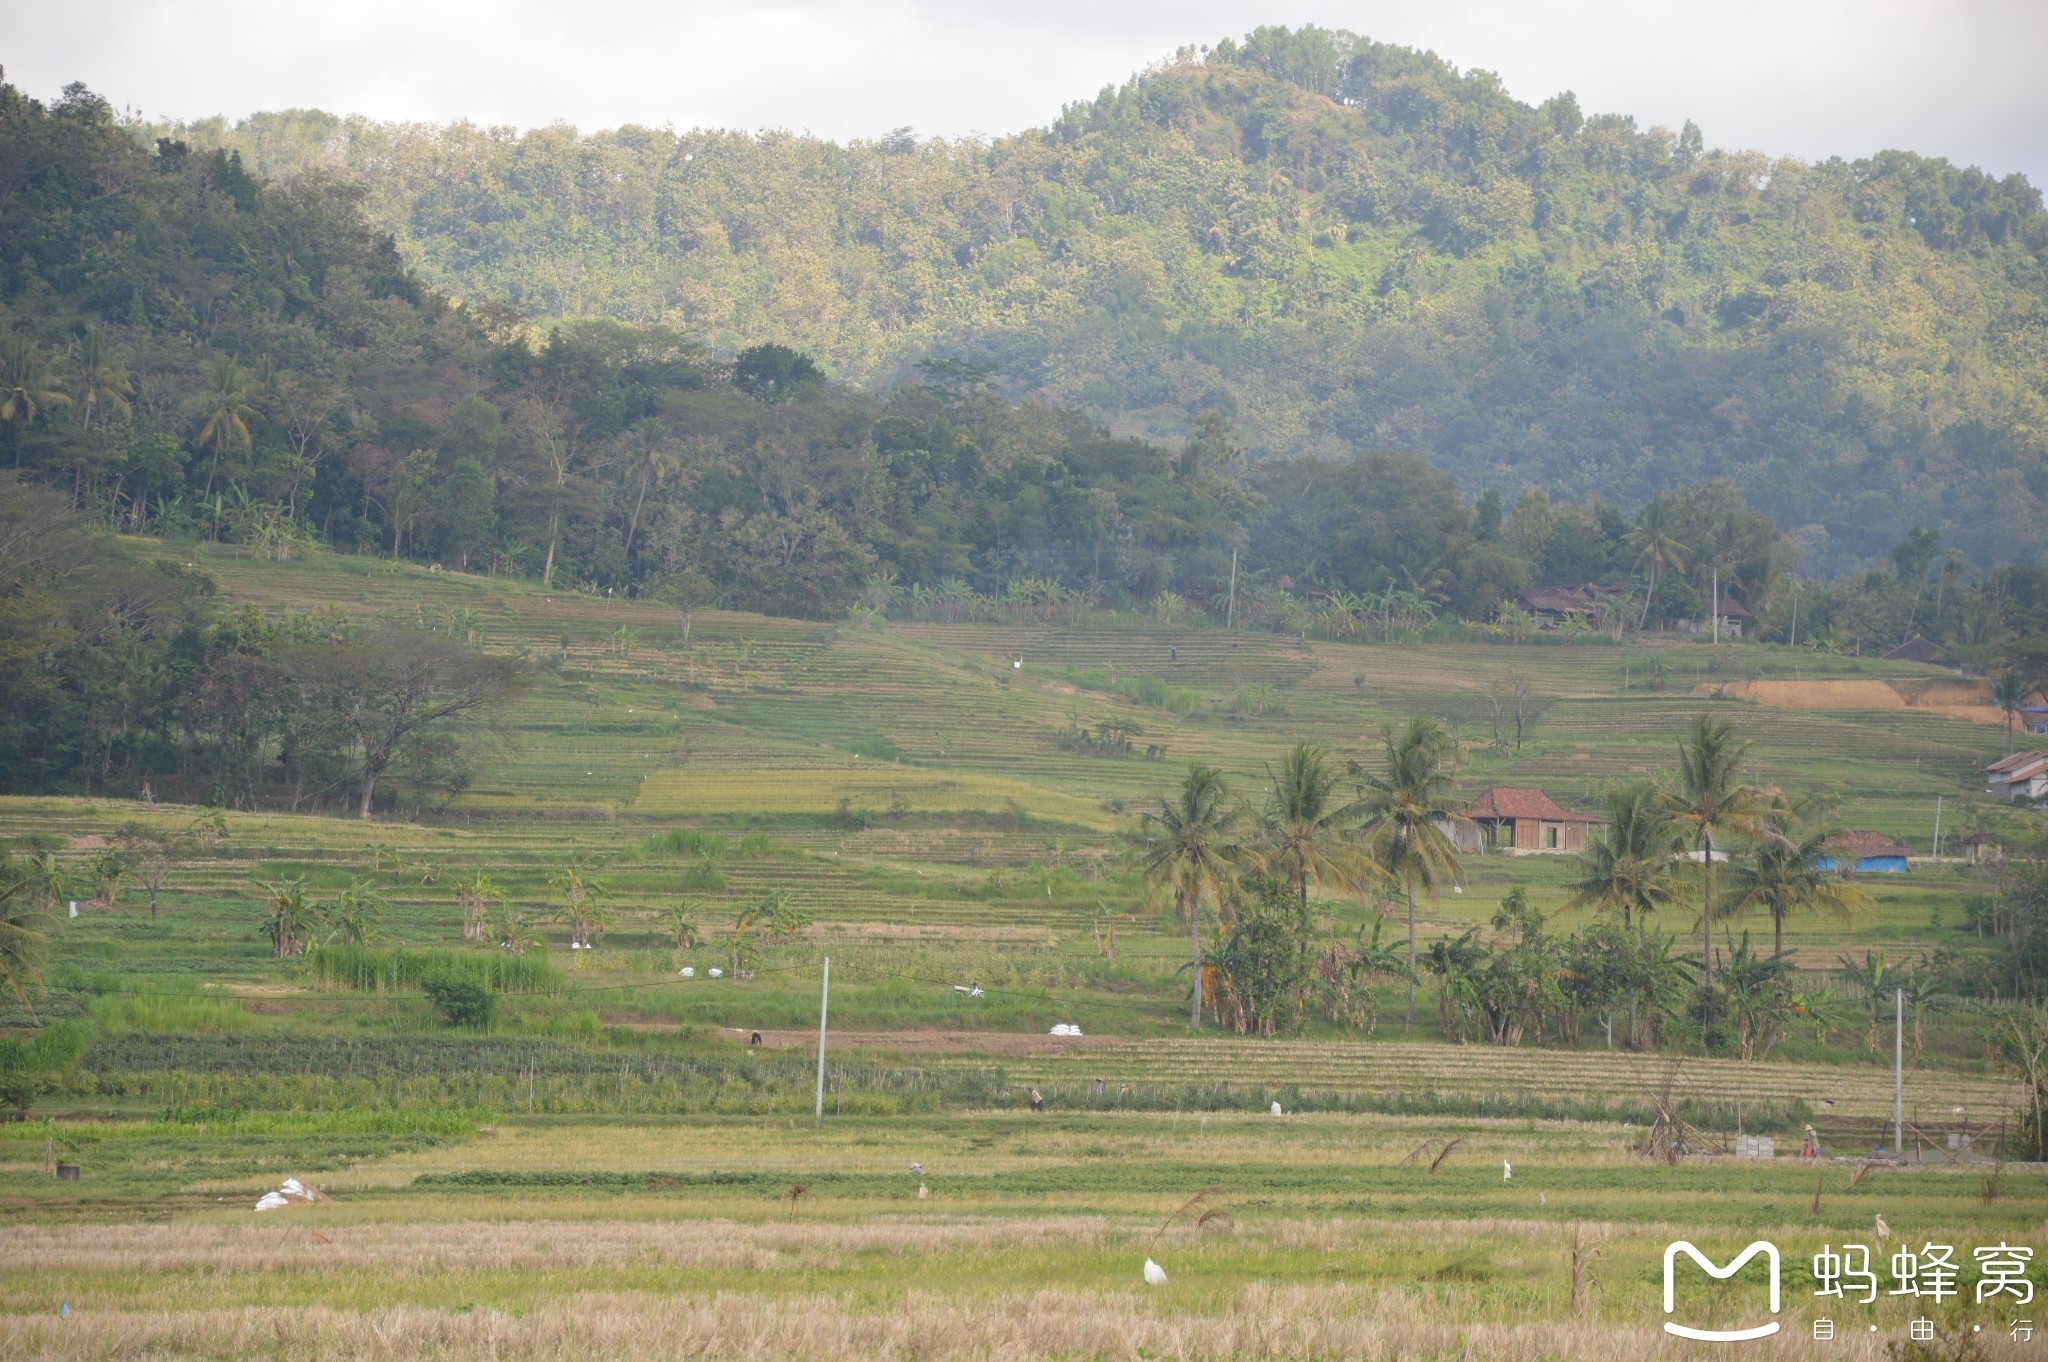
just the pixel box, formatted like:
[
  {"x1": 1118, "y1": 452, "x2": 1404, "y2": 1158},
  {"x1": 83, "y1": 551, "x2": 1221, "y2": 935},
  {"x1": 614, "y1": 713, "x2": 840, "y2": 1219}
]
[{"x1": 167, "y1": 29, "x2": 2048, "y2": 563}]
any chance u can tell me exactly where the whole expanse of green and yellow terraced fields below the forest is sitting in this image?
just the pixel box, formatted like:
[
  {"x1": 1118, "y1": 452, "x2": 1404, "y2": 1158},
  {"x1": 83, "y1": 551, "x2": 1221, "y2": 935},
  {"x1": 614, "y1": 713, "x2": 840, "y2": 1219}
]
[{"x1": 0, "y1": 549, "x2": 2048, "y2": 1360}]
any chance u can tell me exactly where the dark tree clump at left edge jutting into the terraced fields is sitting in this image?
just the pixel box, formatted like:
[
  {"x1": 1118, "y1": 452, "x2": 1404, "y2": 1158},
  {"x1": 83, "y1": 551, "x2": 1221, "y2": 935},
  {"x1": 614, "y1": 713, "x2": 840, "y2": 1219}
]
[{"x1": 0, "y1": 475, "x2": 522, "y2": 802}]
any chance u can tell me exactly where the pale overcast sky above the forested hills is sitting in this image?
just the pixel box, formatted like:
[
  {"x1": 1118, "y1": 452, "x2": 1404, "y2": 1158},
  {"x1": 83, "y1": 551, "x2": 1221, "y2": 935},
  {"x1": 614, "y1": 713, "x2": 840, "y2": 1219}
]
[{"x1": 16, "y1": 0, "x2": 2048, "y2": 184}]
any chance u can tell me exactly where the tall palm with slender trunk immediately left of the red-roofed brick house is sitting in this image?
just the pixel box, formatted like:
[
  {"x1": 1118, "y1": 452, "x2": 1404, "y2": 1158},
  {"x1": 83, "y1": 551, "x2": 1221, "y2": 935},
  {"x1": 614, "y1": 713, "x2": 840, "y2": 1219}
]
[{"x1": 1352, "y1": 717, "x2": 1460, "y2": 1030}]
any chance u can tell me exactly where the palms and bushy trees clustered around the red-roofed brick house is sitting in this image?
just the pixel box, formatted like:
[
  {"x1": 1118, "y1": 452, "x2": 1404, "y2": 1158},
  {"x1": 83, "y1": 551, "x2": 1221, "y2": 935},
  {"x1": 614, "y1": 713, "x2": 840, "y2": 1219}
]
[{"x1": 1130, "y1": 715, "x2": 2044, "y2": 1059}]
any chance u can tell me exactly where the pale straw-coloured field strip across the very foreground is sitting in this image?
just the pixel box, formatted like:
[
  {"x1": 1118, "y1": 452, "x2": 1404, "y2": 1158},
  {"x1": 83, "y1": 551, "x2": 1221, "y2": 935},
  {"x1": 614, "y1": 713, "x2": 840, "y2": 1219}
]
[{"x1": 0, "y1": 1112, "x2": 2048, "y2": 1358}]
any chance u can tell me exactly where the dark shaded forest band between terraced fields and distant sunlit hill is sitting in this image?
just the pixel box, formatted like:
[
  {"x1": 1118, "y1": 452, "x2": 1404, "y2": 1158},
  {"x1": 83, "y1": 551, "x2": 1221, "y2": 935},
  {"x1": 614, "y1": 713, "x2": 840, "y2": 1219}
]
[{"x1": 0, "y1": 74, "x2": 2048, "y2": 647}]
